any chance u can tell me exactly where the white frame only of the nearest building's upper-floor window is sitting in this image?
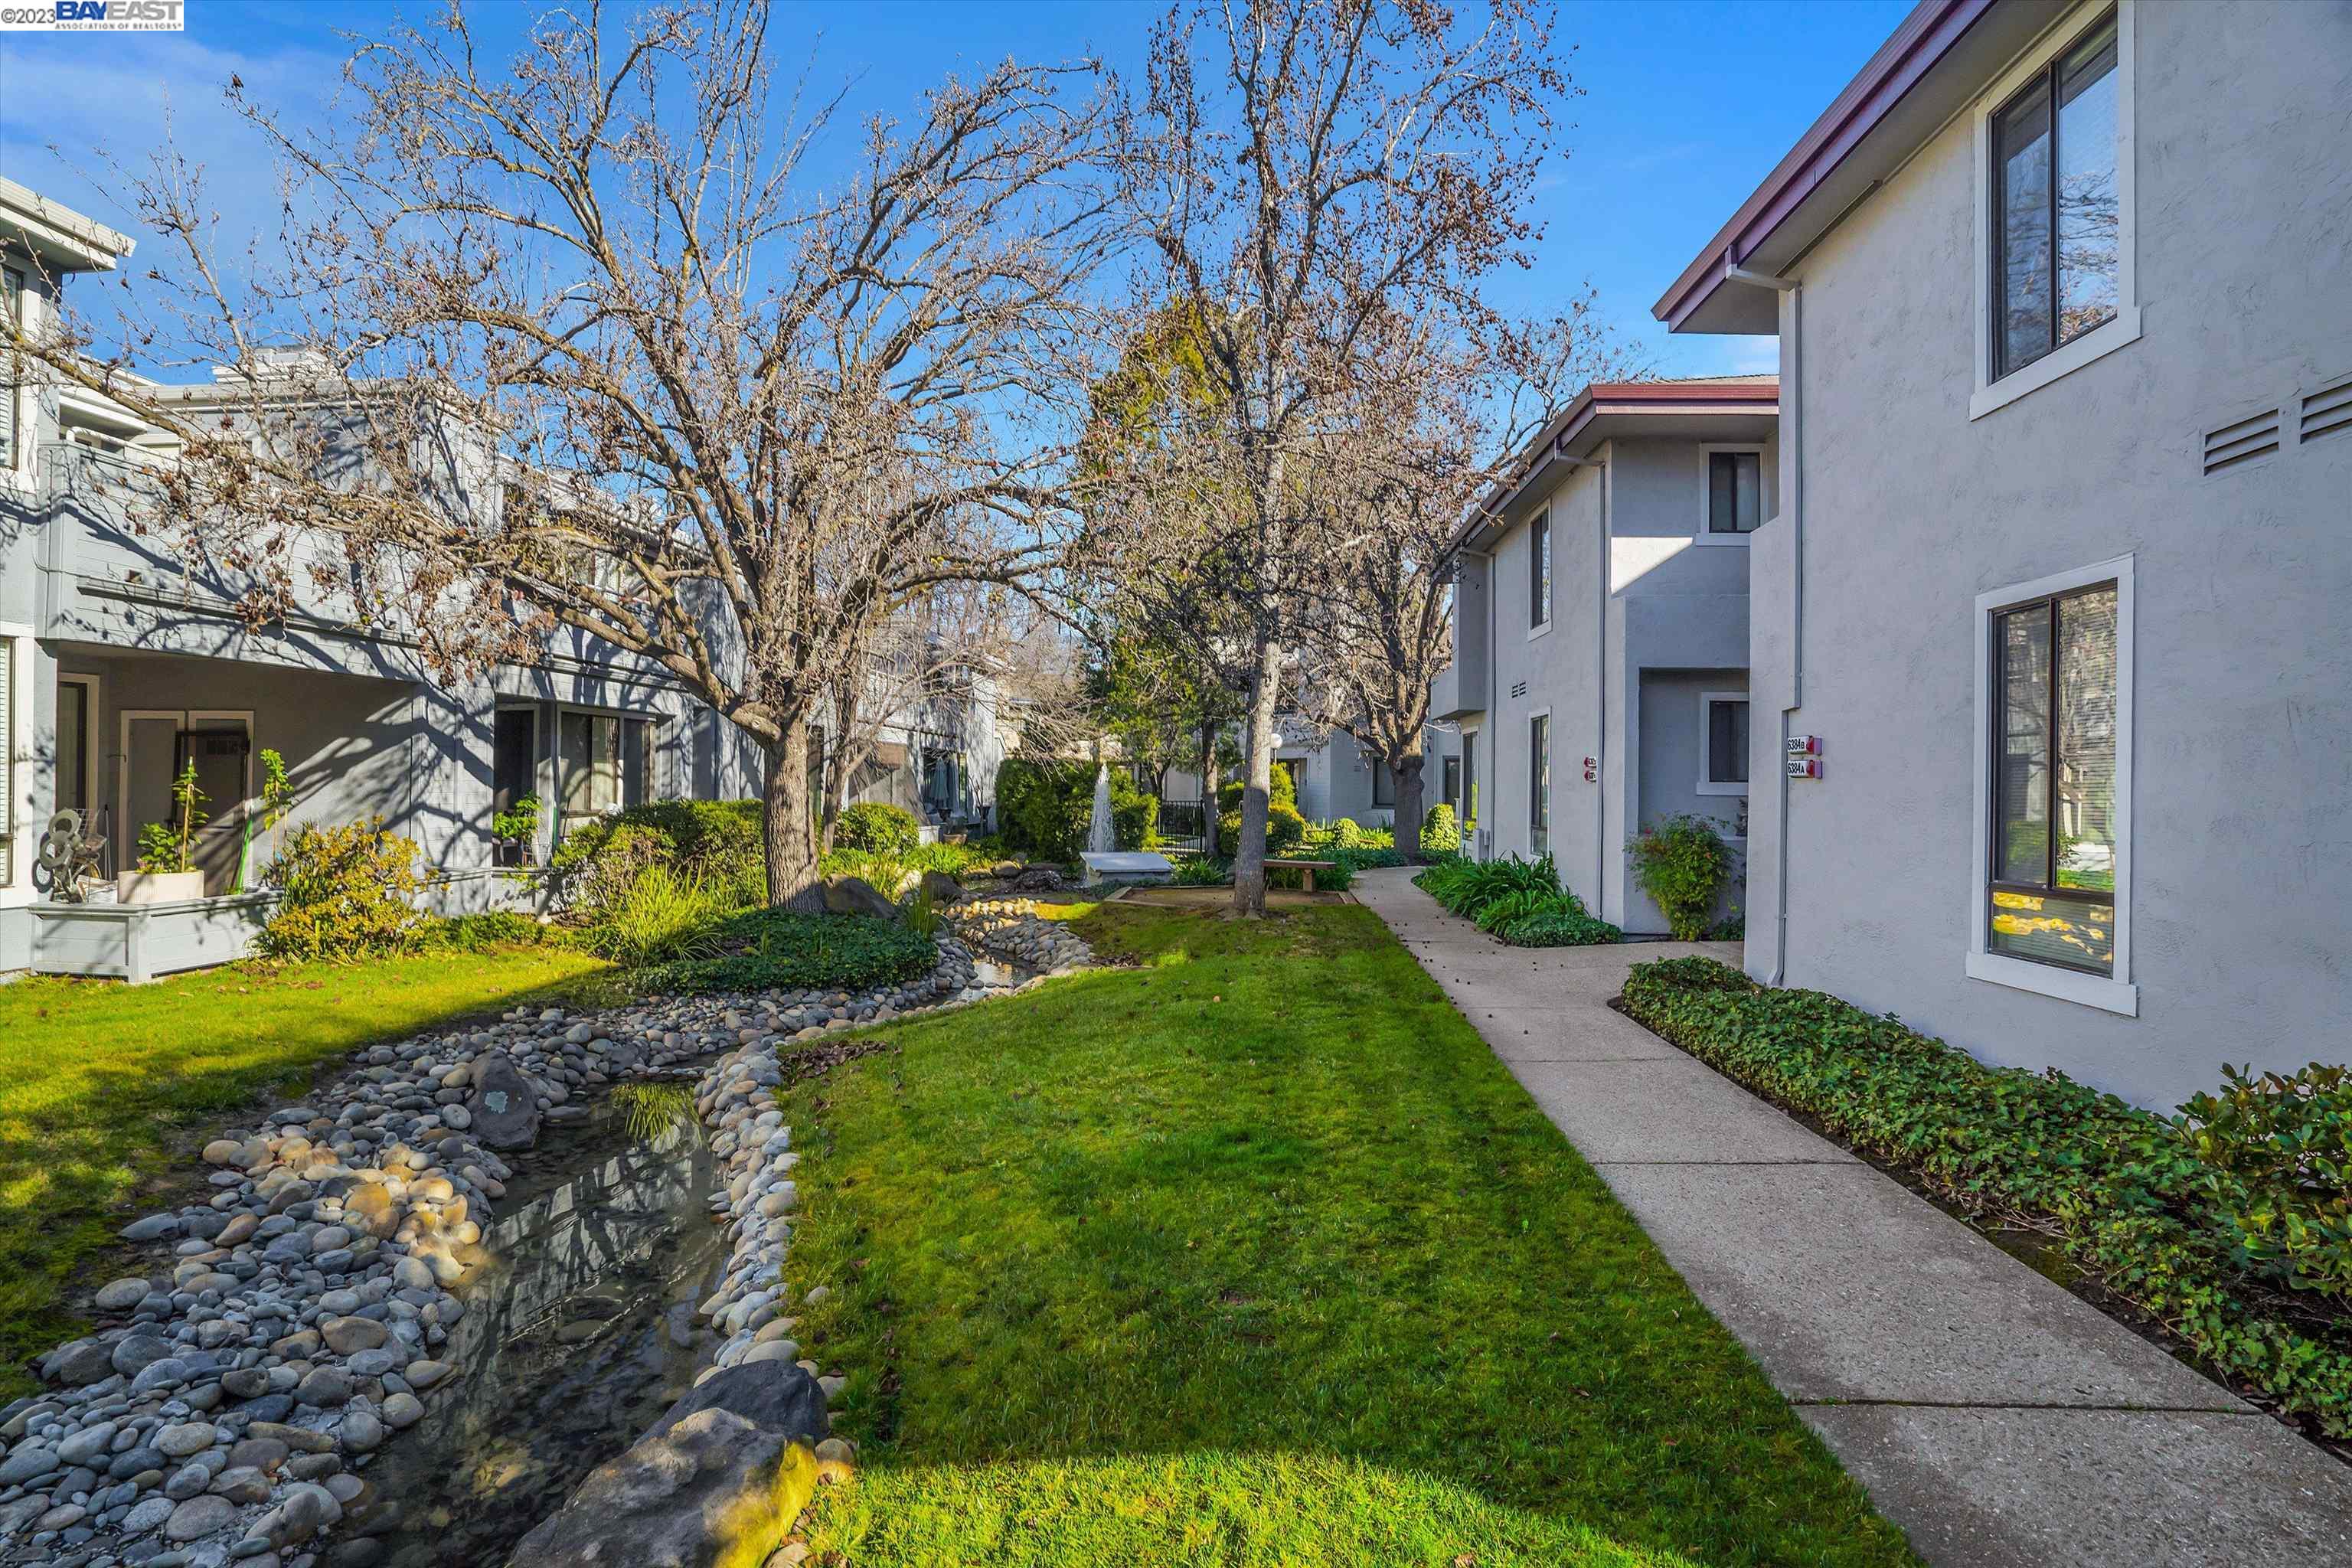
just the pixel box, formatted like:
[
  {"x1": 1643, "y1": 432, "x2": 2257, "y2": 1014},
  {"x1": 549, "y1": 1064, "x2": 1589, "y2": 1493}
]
[{"x1": 1968, "y1": 0, "x2": 2141, "y2": 419}]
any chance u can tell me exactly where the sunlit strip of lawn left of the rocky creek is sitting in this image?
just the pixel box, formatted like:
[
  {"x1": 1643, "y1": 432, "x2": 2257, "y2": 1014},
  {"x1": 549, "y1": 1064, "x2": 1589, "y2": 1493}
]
[{"x1": 0, "y1": 945, "x2": 605, "y2": 1399}]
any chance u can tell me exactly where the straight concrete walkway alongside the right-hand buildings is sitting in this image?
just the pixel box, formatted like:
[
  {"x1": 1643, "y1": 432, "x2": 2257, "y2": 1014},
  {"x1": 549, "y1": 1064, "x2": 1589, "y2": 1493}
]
[{"x1": 1354, "y1": 870, "x2": 2352, "y2": 1568}]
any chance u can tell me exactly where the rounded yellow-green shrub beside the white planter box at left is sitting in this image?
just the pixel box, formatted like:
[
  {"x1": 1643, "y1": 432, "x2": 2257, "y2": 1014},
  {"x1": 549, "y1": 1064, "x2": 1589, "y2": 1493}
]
[{"x1": 259, "y1": 818, "x2": 426, "y2": 959}]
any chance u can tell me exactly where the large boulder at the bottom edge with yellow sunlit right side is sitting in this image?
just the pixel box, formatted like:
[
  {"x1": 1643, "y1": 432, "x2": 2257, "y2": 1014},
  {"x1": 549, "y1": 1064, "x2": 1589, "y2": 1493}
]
[{"x1": 508, "y1": 1361, "x2": 828, "y2": 1568}]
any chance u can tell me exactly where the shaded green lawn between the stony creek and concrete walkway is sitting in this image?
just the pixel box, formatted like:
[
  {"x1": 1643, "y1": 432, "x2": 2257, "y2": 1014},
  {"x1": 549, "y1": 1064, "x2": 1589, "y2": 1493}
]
[{"x1": 790, "y1": 905, "x2": 1915, "y2": 1568}]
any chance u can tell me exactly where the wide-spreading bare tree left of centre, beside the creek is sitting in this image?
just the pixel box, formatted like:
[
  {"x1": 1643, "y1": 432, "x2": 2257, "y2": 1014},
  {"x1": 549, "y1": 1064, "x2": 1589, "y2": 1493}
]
[{"x1": 11, "y1": 0, "x2": 1115, "y2": 903}]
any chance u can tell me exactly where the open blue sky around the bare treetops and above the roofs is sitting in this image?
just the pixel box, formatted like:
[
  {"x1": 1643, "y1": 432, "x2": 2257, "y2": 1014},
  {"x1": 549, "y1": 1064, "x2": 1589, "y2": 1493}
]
[{"x1": 0, "y1": 0, "x2": 1909, "y2": 374}]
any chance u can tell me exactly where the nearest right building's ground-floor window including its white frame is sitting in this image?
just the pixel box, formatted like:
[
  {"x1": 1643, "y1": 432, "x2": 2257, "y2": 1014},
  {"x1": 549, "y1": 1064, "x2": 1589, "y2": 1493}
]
[{"x1": 1968, "y1": 560, "x2": 2138, "y2": 1013}]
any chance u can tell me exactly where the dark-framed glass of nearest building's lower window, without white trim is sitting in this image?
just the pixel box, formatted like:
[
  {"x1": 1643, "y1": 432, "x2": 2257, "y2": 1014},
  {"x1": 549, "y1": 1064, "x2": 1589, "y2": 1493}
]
[{"x1": 1985, "y1": 583, "x2": 2117, "y2": 975}]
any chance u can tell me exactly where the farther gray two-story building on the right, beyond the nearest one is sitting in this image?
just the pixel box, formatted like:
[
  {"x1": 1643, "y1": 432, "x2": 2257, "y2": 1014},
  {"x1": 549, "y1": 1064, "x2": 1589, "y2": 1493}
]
[{"x1": 1426, "y1": 376, "x2": 1778, "y2": 933}]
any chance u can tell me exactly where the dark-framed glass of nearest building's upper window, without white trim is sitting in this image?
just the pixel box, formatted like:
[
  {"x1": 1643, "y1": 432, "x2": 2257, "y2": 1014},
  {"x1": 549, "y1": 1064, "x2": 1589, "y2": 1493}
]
[{"x1": 1992, "y1": 16, "x2": 2122, "y2": 378}]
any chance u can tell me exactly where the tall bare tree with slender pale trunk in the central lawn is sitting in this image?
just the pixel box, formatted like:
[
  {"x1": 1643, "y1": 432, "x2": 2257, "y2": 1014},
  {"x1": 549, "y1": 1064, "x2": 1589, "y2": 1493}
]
[{"x1": 1119, "y1": 0, "x2": 1569, "y2": 914}]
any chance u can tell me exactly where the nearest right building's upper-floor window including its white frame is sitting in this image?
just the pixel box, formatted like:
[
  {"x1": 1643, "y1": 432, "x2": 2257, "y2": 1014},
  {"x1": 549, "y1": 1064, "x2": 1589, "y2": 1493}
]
[{"x1": 1968, "y1": 0, "x2": 2141, "y2": 419}]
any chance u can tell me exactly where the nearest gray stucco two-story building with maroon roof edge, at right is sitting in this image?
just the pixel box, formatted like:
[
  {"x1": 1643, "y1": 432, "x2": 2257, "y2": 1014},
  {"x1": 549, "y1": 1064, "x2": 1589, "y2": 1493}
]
[{"x1": 1655, "y1": 0, "x2": 2352, "y2": 1109}]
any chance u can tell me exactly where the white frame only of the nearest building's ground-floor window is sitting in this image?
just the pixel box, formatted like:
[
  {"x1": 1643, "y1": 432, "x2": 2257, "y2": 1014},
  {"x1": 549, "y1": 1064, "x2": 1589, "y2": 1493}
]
[{"x1": 1966, "y1": 555, "x2": 2141, "y2": 1018}]
